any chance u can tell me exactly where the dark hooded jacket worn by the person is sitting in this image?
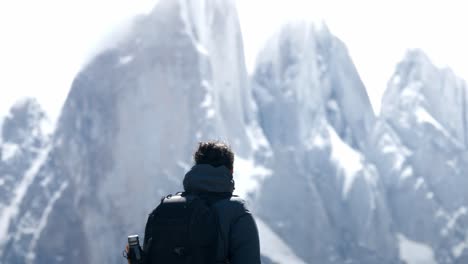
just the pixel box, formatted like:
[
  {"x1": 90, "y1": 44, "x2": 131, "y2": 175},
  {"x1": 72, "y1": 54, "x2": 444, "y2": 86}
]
[{"x1": 144, "y1": 164, "x2": 260, "y2": 264}]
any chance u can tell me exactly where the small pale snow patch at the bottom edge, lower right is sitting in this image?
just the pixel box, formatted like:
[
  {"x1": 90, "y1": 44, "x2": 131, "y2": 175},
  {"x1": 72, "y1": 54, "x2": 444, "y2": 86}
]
[{"x1": 397, "y1": 233, "x2": 437, "y2": 264}]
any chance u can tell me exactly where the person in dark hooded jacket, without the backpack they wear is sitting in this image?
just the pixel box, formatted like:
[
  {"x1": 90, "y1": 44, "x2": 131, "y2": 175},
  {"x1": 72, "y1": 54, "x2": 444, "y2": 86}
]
[{"x1": 127, "y1": 141, "x2": 261, "y2": 264}]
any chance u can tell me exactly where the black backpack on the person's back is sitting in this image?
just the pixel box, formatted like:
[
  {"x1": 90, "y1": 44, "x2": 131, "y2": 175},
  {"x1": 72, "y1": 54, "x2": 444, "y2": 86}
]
[{"x1": 144, "y1": 193, "x2": 228, "y2": 264}]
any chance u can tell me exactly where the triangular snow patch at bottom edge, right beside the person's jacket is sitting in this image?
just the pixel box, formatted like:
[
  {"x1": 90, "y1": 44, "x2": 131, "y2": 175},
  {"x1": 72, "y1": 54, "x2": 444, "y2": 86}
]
[{"x1": 255, "y1": 218, "x2": 306, "y2": 264}]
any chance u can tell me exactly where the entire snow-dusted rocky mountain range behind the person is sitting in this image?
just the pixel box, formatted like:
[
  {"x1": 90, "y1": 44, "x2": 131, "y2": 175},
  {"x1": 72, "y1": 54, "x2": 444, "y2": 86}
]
[{"x1": 0, "y1": 0, "x2": 468, "y2": 264}]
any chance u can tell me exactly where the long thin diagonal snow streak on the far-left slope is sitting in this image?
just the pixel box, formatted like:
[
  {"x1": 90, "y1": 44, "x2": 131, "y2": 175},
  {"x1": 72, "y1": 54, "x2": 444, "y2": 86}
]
[{"x1": 0, "y1": 146, "x2": 51, "y2": 255}]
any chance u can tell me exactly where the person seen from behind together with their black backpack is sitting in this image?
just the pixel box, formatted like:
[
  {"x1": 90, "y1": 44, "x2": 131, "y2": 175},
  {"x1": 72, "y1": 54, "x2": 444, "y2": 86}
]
[{"x1": 126, "y1": 141, "x2": 261, "y2": 264}]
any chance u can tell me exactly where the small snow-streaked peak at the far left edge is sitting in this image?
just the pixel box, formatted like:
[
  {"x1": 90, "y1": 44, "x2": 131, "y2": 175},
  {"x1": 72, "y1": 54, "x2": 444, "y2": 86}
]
[{"x1": 0, "y1": 99, "x2": 61, "y2": 263}]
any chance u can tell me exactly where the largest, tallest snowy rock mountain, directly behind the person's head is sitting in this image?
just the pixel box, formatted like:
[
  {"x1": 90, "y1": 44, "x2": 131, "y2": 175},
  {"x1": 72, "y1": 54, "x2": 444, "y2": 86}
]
[{"x1": 0, "y1": 0, "x2": 269, "y2": 263}]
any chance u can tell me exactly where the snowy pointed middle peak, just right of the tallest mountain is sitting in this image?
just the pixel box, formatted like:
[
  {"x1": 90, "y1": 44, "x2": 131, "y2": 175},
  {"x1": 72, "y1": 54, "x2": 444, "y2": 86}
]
[{"x1": 253, "y1": 23, "x2": 398, "y2": 263}]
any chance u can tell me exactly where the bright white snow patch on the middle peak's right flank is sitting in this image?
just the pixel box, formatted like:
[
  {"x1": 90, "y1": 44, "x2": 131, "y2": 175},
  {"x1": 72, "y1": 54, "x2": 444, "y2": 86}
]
[{"x1": 327, "y1": 126, "x2": 364, "y2": 198}]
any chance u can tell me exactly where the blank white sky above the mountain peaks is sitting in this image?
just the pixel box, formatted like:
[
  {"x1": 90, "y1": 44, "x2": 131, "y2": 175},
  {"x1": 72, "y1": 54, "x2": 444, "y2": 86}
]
[{"x1": 0, "y1": 0, "x2": 468, "y2": 122}]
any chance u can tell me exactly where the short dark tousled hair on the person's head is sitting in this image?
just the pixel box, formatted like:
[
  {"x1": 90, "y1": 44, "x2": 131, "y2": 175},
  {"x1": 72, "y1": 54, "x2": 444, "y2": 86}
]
[{"x1": 193, "y1": 141, "x2": 234, "y2": 170}]
